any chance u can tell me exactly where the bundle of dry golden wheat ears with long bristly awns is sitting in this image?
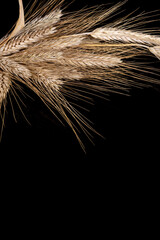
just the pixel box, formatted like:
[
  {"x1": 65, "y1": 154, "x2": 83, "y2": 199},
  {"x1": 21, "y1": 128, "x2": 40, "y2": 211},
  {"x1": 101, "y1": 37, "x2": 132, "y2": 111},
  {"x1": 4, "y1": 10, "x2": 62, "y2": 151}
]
[{"x1": 0, "y1": 0, "x2": 160, "y2": 150}]
